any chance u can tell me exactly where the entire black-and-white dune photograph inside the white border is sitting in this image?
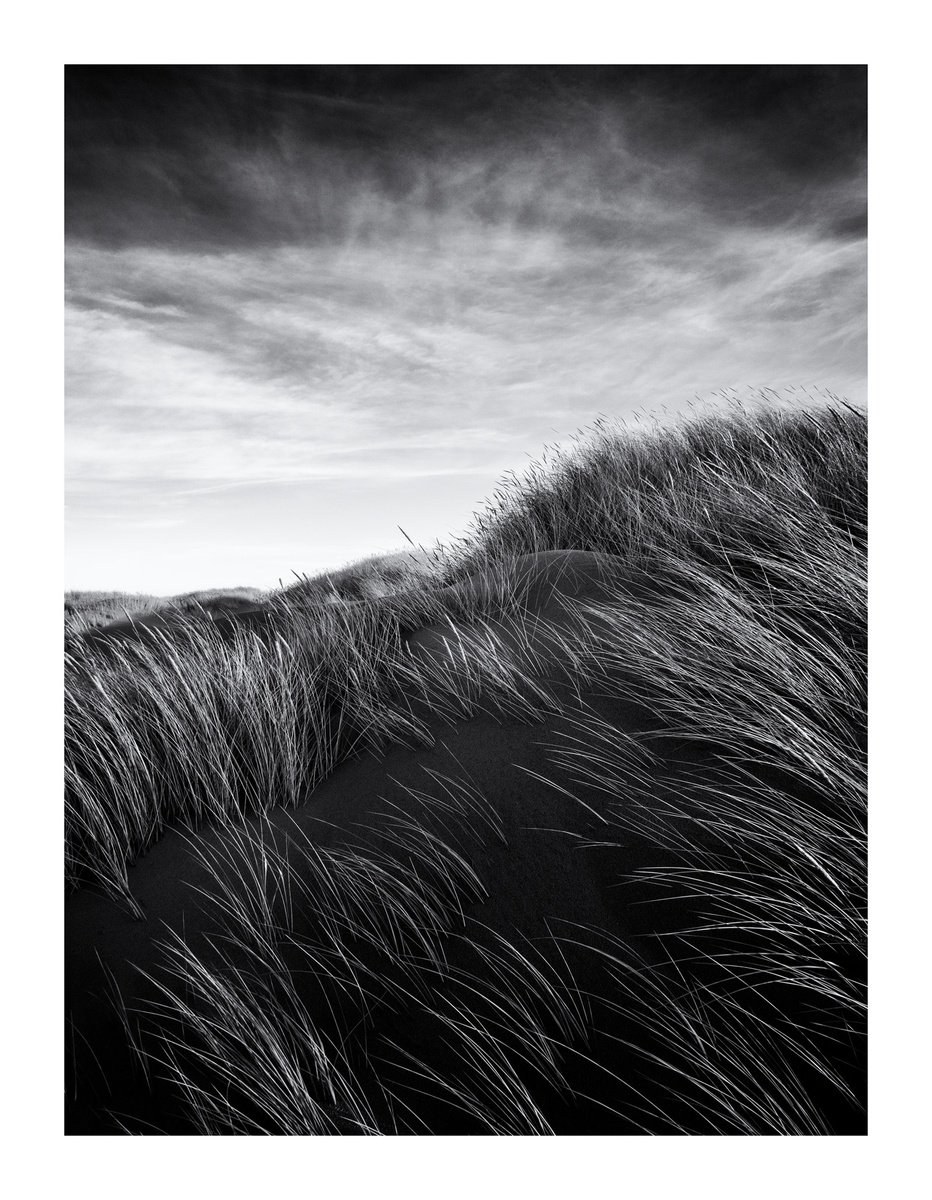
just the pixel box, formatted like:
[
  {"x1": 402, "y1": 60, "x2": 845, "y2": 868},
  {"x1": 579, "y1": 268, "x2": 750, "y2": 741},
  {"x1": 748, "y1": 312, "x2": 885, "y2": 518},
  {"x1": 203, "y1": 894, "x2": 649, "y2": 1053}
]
[{"x1": 63, "y1": 60, "x2": 868, "y2": 1137}]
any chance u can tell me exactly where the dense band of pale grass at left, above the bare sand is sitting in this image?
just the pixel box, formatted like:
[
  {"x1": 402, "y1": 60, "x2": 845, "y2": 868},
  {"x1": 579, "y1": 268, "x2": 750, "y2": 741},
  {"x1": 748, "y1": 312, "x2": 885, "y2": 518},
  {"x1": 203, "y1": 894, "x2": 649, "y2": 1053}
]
[{"x1": 65, "y1": 556, "x2": 566, "y2": 904}]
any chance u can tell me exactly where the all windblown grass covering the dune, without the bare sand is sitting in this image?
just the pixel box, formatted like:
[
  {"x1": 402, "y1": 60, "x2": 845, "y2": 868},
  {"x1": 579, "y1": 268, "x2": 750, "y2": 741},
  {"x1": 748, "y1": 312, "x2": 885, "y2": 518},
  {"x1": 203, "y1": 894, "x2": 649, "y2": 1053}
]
[{"x1": 66, "y1": 403, "x2": 866, "y2": 1134}]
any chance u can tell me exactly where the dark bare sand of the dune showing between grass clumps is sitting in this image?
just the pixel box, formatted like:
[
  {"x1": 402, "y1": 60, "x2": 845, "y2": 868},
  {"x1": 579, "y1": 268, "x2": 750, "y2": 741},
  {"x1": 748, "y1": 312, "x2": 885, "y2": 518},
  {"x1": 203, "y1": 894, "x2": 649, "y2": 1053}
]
[{"x1": 66, "y1": 552, "x2": 856, "y2": 1133}]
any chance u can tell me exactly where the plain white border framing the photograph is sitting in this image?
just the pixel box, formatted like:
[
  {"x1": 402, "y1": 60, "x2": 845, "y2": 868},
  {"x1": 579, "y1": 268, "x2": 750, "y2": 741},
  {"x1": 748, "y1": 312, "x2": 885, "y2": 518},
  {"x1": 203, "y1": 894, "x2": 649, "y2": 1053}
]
[{"x1": 2, "y1": 7, "x2": 932, "y2": 1200}]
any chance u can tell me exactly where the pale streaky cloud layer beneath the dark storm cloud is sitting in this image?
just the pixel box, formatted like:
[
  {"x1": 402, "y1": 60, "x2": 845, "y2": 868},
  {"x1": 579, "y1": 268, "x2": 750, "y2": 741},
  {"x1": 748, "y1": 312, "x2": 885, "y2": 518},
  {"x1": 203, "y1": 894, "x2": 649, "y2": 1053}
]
[{"x1": 68, "y1": 212, "x2": 864, "y2": 481}]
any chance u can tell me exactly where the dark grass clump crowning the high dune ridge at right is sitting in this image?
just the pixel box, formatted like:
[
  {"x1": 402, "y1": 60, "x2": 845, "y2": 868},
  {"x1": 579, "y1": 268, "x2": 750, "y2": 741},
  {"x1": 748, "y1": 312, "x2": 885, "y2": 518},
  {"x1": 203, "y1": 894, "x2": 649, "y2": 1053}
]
[{"x1": 446, "y1": 397, "x2": 867, "y2": 584}]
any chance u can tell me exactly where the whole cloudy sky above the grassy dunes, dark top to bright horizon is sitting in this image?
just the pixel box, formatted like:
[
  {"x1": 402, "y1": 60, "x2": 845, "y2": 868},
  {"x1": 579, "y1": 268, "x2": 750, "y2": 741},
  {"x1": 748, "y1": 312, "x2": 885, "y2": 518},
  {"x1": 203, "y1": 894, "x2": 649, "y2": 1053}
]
[{"x1": 65, "y1": 66, "x2": 866, "y2": 594}]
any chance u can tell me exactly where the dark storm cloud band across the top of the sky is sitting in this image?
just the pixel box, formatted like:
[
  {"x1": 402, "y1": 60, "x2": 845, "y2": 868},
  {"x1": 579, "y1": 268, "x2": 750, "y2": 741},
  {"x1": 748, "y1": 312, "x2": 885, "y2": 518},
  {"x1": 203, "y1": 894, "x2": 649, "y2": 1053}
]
[{"x1": 66, "y1": 67, "x2": 866, "y2": 248}]
